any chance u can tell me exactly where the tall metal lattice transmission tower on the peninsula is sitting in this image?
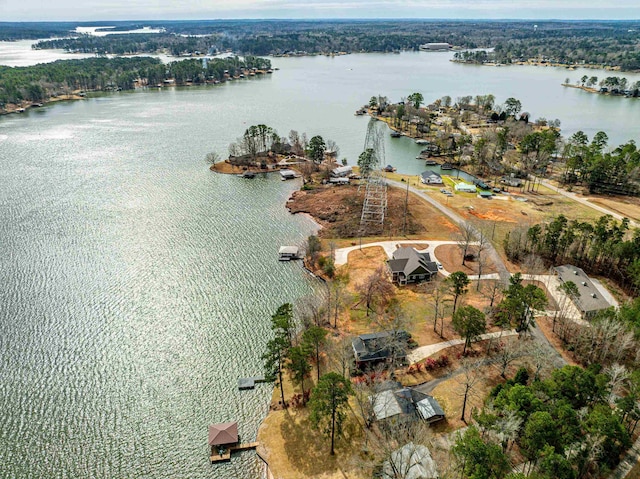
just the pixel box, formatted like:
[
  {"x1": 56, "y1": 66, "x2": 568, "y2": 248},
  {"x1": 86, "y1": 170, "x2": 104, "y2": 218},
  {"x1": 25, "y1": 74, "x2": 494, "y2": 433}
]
[{"x1": 360, "y1": 118, "x2": 387, "y2": 236}]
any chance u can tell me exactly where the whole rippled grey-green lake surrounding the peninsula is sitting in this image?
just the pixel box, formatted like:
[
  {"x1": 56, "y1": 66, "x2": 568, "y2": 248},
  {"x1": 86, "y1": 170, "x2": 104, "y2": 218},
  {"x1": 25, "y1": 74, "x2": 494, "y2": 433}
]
[{"x1": 0, "y1": 43, "x2": 640, "y2": 479}]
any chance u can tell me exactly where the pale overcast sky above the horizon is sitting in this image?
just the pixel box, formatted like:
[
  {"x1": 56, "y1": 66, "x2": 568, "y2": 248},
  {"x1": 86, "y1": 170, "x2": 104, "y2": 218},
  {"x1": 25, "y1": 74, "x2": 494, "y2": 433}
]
[{"x1": 5, "y1": 0, "x2": 640, "y2": 21}]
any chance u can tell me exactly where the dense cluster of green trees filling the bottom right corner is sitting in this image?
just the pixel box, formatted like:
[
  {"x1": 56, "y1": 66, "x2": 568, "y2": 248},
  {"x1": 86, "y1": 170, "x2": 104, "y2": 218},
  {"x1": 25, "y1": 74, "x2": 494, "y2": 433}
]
[{"x1": 452, "y1": 365, "x2": 640, "y2": 479}]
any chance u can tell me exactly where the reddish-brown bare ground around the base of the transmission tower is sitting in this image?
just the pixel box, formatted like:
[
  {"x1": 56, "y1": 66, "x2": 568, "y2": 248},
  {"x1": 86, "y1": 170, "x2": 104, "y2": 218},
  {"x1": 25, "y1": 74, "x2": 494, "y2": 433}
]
[{"x1": 287, "y1": 185, "x2": 457, "y2": 239}]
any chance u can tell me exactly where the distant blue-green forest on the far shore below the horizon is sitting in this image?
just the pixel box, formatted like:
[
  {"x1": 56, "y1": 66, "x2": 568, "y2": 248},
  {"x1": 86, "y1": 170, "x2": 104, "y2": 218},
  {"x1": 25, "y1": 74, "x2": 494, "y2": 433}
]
[{"x1": 18, "y1": 20, "x2": 640, "y2": 70}]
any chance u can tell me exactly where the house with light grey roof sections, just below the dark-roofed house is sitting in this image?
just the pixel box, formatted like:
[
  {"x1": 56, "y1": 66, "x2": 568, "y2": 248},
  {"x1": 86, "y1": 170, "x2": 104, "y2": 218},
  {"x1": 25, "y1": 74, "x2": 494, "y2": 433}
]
[{"x1": 369, "y1": 381, "x2": 445, "y2": 423}]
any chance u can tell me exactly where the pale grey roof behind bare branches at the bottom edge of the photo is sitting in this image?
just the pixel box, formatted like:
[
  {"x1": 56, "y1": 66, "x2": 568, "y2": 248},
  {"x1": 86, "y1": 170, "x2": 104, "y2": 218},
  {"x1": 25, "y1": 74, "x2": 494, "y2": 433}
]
[{"x1": 382, "y1": 442, "x2": 439, "y2": 479}]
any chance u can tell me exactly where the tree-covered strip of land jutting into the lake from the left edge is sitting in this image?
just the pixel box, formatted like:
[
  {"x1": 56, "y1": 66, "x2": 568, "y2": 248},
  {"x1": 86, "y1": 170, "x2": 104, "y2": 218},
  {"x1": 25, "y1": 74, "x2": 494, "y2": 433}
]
[{"x1": 0, "y1": 56, "x2": 271, "y2": 107}]
